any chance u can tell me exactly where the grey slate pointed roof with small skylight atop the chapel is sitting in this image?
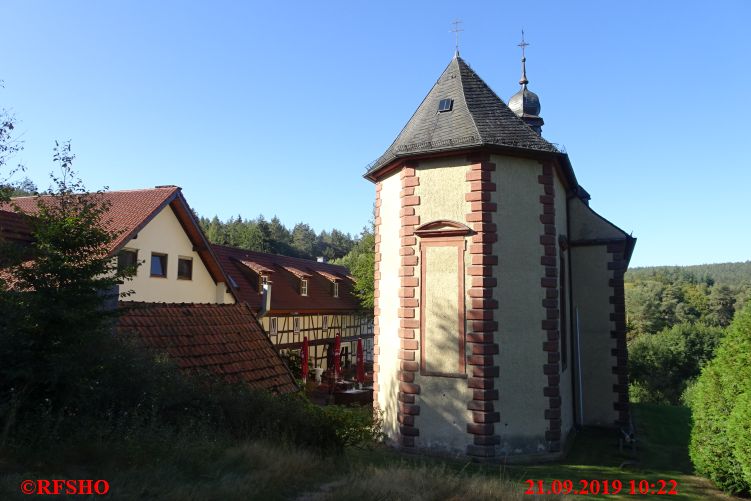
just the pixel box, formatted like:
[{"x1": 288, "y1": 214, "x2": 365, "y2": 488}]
[{"x1": 366, "y1": 56, "x2": 558, "y2": 176}]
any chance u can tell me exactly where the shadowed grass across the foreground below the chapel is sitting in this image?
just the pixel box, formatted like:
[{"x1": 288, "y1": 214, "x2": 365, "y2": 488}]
[{"x1": 0, "y1": 404, "x2": 733, "y2": 501}]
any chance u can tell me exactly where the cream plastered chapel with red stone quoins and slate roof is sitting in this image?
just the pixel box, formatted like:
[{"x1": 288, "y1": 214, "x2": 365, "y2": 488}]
[{"x1": 365, "y1": 41, "x2": 634, "y2": 459}]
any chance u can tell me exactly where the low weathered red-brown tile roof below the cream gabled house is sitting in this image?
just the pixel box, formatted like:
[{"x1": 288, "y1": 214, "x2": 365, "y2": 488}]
[{"x1": 117, "y1": 302, "x2": 297, "y2": 393}]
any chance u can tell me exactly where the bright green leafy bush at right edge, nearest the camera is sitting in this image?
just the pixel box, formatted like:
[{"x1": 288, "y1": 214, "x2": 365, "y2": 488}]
[{"x1": 689, "y1": 307, "x2": 751, "y2": 494}]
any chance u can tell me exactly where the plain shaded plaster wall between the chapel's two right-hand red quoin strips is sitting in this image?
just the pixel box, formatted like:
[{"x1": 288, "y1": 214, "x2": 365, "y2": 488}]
[{"x1": 492, "y1": 155, "x2": 548, "y2": 455}]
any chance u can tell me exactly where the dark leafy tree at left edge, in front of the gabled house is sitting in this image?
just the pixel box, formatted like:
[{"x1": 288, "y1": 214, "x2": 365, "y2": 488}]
[{"x1": 0, "y1": 143, "x2": 135, "y2": 432}]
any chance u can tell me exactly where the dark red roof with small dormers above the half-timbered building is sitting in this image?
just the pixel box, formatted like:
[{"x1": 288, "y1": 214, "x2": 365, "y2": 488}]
[{"x1": 212, "y1": 245, "x2": 360, "y2": 313}]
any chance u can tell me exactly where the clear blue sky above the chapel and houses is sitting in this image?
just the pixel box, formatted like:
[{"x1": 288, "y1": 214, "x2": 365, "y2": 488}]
[{"x1": 0, "y1": 0, "x2": 751, "y2": 266}]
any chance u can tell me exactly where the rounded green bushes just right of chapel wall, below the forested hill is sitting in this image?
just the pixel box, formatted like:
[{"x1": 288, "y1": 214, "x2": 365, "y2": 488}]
[{"x1": 629, "y1": 323, "x2": 724, "y2": 405}]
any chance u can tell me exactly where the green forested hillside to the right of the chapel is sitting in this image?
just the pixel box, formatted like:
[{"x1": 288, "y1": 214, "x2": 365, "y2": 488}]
[{"x1": 625, "y1": 262, "x2": 751, "y2": 404}]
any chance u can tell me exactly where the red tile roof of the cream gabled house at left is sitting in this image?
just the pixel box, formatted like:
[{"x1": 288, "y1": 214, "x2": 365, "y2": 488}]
[{"x1": 0, "y1": 186, "x2": 232, "y2": 292}]
